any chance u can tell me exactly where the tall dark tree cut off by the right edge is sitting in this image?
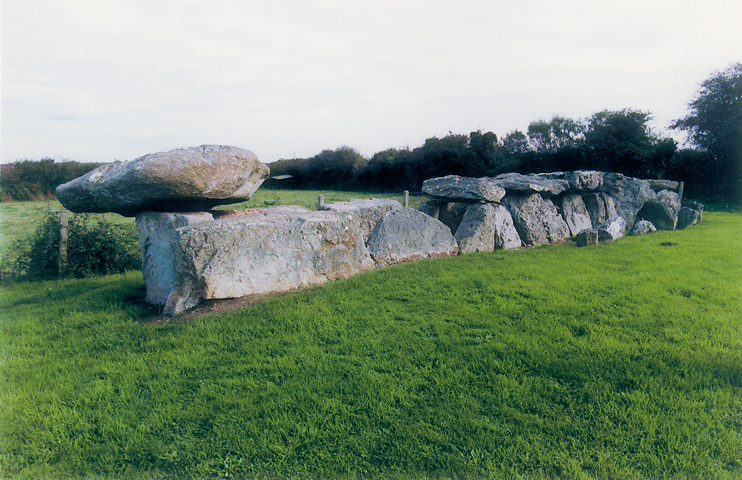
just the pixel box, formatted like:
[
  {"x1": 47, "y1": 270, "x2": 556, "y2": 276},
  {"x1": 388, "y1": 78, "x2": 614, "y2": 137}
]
[{"x1": 671, "y1": 63, "x2": 742, "y2": 184}]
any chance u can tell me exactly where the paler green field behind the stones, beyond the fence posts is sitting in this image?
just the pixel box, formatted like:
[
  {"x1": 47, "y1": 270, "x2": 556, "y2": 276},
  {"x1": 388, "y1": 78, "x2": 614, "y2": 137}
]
[{"x1": 0, "y1": 188, "x2": 423, "y2": 252}]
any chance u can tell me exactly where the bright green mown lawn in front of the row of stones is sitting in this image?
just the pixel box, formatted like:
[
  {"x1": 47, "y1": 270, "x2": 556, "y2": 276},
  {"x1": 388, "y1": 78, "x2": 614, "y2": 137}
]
[{"x1": 0, "y1": 213, "x2": 742, "y2": 479}]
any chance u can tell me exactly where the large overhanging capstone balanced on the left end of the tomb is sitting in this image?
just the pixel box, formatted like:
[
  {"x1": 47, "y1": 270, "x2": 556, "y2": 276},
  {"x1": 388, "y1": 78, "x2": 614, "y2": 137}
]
[{"x1": 56, "y1": 145, "x2": 270, "y2": 216}]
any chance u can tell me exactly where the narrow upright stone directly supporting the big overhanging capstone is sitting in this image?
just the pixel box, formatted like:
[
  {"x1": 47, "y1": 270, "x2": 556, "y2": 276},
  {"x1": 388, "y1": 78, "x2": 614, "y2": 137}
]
[{"x1": 137, "y1": 212, "x2": 213, "y2": 310}]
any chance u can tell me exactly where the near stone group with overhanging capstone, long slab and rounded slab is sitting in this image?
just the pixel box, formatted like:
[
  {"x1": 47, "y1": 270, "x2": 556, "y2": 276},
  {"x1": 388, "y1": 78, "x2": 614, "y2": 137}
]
[{"x1": 57, "y1": 145, "x2": 458, "y2": 315}]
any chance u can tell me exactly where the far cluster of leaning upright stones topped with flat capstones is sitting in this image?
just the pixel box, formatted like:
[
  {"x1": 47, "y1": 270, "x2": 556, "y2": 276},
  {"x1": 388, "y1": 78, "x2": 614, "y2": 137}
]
[{"x1": 419, "y1": 171, "x2": 703, "y2": 253}]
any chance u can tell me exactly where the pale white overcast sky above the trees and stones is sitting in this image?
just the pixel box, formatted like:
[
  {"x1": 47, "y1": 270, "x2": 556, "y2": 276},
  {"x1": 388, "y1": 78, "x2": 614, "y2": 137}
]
[{"x1": 0, "y1": 0, "x2": 742, "y2": 163}]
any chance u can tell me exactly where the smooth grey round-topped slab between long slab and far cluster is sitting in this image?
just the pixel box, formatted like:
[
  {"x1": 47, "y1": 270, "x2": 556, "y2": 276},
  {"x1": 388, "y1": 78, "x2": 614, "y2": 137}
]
[{"x1": 367, "y1": 207, "x2": 459, "y2": 267}]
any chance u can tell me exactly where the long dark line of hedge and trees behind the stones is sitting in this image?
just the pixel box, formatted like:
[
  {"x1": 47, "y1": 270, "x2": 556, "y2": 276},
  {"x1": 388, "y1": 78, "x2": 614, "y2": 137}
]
[{"x1": 270, "y1": 110, "x2": 702, "y2": 191}]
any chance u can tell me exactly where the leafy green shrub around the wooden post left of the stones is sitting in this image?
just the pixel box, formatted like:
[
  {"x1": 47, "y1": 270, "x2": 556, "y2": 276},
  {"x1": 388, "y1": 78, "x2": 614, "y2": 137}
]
[{"x1": 2, "y1": 211, "x2": 141, "y2": 281}]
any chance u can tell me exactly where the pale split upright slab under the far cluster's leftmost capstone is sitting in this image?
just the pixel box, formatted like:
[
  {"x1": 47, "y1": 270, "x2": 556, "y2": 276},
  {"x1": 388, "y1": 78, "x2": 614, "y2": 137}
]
[{"x1": 454, "y1": 203, "x2": 522, "y2": 254}]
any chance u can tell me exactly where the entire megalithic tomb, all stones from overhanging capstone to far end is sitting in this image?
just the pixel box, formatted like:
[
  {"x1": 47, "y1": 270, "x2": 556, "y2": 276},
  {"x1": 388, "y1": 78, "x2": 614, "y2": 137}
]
[{"x1": 57, "y1": 145, "x2": 703, "y2": 315}]
